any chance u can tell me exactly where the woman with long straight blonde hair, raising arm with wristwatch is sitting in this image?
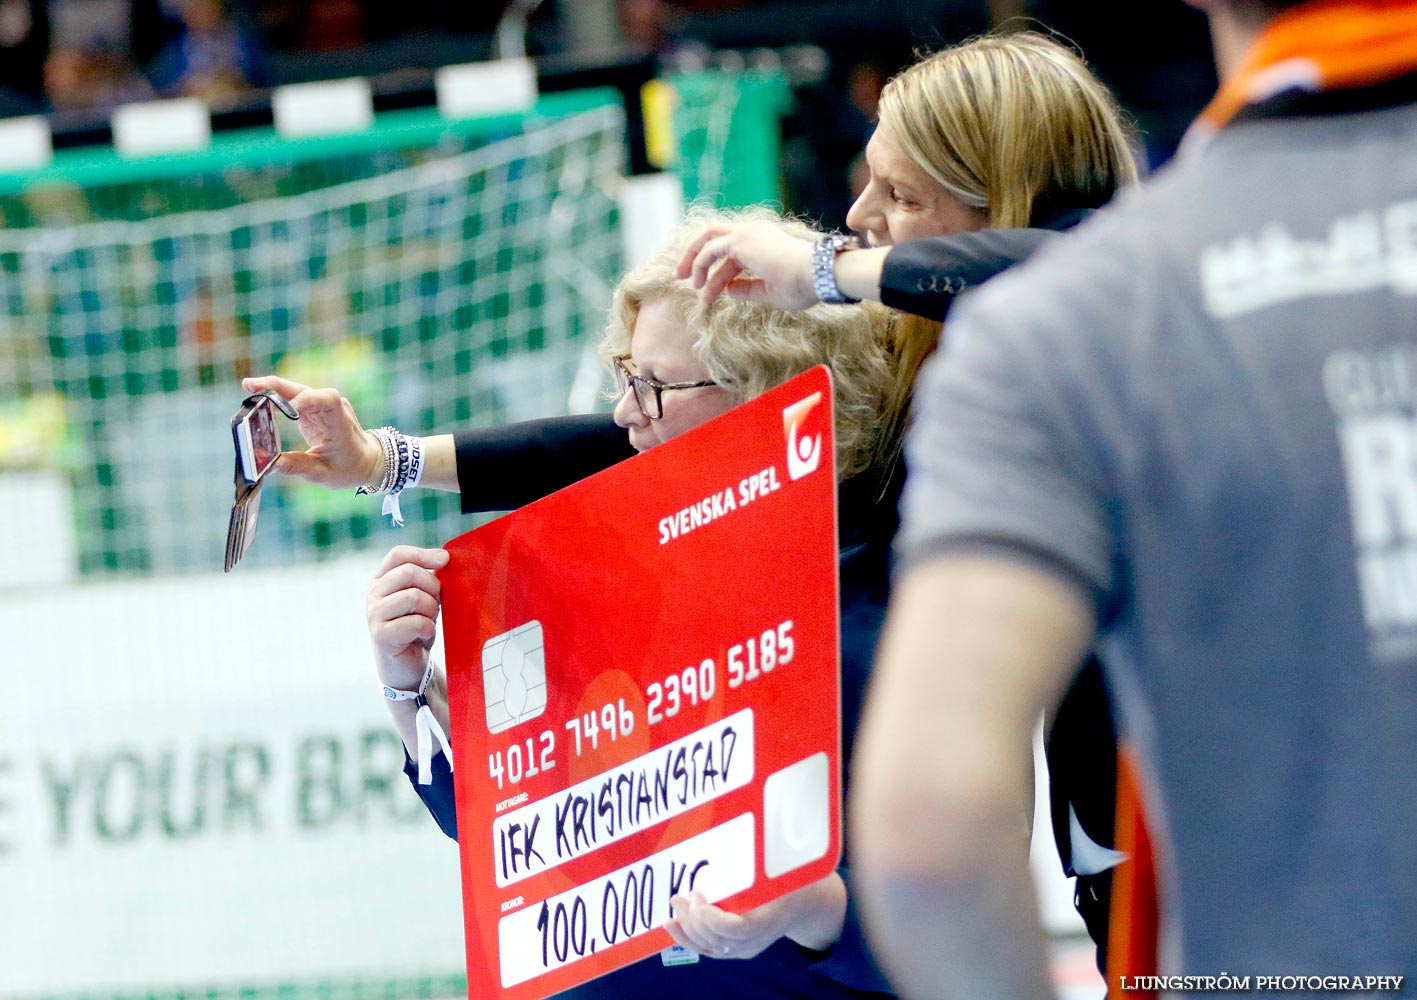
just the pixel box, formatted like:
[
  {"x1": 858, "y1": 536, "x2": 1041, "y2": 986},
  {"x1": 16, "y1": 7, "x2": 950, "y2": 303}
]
[{"x1": 679, "y1": 33, "x2": 1138, "y2": 967}]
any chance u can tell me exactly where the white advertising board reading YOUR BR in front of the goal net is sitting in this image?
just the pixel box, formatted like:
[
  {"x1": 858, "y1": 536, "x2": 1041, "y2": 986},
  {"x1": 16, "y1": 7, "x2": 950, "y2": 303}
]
[{"x1": 0, "y1": 552, "x2": 463, "y2": 997}]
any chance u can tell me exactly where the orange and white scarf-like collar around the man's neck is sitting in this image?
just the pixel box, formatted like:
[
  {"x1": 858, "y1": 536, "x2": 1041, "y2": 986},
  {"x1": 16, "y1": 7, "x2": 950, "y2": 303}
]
[{"x1": 1195, "y1": 0, "x2": 1417, "y2": 135}]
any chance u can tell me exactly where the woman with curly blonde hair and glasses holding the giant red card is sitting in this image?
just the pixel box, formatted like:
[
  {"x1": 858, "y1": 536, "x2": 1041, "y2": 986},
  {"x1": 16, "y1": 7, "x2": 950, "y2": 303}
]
[{"x1": 267, "y1": 211, "x2": 896, "y2": 1000}]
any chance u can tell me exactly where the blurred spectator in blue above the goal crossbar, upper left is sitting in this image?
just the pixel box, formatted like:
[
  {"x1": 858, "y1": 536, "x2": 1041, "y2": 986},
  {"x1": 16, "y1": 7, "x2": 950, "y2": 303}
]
[{"x1": 150, "y1": 0, "x2": 266, "y2": 103}]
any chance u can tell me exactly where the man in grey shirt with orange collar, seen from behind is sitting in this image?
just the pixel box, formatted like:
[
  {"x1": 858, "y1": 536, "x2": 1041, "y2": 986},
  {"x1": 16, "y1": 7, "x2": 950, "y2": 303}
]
[{"x1": 842, "y1": 0, "x2": 1417, "y2": 997}]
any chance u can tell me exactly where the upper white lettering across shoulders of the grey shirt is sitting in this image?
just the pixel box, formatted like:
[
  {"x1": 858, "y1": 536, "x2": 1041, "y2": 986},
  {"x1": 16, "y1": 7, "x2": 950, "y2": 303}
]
[{"x1": 1200, "y1": 200, "x2": 1417, "y2": 319}]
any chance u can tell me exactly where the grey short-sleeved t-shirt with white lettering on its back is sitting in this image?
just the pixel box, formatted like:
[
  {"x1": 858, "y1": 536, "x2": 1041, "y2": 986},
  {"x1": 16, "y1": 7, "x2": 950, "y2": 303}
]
[{"x1": 898, "y1": 106, "x2": 1417, "y2": 993}]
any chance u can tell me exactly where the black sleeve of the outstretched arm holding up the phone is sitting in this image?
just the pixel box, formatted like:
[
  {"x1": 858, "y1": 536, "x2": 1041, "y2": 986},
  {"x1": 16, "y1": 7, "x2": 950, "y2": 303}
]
[{"x1": 453, "y1": 414, "x2": 635, "y2": 514}]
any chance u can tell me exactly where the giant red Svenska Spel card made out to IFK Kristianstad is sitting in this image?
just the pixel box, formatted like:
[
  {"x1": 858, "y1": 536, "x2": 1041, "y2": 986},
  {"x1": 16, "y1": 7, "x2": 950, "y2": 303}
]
[{"x1": 441, "y1": 368, "x2": 842, "y2": 1000}]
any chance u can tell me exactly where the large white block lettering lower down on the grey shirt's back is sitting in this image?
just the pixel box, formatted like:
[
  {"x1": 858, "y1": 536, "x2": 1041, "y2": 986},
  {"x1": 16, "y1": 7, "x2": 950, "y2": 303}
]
[{"x1": 1323, "y1": 347, "x2": 1417, "y2": 643}]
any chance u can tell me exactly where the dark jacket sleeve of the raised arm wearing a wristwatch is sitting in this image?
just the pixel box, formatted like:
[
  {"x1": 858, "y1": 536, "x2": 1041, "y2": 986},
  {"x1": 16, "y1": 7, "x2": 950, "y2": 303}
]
[{"x1": 881, "y1": 229, "x2": 1057, "y2": 320}]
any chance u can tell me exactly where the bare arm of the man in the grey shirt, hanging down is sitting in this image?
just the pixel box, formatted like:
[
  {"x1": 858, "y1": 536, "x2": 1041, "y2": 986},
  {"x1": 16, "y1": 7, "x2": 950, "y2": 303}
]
[{"x1": 847, "y1": 554, "x2": 1094, "y2": 999}]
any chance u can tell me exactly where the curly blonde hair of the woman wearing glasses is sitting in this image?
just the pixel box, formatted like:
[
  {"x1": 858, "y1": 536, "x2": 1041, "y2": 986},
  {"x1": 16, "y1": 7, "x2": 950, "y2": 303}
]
[{"x1": 599, "y1": 208, "x2": 893, "y2": 479}]
